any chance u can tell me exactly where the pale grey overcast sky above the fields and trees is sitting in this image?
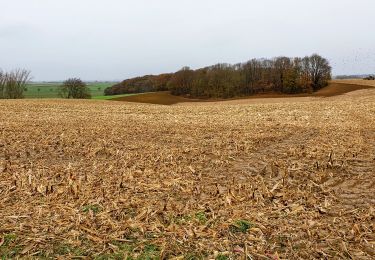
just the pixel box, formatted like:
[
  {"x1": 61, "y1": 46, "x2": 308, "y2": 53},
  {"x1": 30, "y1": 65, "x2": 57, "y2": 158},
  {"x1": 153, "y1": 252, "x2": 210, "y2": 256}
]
[{"x1": 0, "y1": 0, "x2": 375, "y2": 80}]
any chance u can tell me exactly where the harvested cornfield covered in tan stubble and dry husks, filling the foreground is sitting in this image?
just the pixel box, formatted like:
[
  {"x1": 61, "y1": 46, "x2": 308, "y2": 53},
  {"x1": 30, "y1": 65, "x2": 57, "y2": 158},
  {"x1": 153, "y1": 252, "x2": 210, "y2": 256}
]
[{"x1": 0, "y1": 90, "x2": 375, "y2": 259}]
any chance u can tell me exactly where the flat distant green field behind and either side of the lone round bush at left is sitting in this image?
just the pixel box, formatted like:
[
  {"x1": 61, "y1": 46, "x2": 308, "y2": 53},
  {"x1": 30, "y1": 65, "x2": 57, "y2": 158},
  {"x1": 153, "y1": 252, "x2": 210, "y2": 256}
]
[{"x1": 24, "y1": 82, "x2": 115, "y2": 99}]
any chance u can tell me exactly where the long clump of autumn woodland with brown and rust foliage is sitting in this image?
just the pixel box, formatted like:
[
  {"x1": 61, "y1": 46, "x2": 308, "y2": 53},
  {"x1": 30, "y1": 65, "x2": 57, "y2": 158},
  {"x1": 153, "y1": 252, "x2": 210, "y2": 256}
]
[{"x1": 105, "y1": 54, "x2": 331, "y2": 98}]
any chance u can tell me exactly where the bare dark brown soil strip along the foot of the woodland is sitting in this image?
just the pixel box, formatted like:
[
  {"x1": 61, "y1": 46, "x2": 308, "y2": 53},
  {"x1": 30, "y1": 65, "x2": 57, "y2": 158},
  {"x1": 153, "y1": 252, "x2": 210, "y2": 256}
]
[{"x1": 111, "y1": 82, "x2": 374, "y2": 105}]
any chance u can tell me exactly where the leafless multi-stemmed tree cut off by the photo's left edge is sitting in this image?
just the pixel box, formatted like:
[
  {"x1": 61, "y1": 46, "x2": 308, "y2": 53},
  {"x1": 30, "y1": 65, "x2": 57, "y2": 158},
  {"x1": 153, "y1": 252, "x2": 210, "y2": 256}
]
[{"x1": 0, "y1": 69, "x2": 31, "y2": 99}]
